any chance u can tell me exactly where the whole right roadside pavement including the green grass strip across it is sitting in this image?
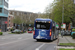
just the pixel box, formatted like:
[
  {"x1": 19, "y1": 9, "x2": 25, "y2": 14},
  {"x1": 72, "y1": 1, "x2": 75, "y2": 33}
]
[{"x1": 56, "y1": 35, "x2": 75, "y2": 50}]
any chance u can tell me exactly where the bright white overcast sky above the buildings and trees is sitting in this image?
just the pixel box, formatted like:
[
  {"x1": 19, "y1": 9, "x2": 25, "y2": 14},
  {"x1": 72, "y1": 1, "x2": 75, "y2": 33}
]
[{"x1": 9, "y1": 0, "x2": 54, "y2": 13}]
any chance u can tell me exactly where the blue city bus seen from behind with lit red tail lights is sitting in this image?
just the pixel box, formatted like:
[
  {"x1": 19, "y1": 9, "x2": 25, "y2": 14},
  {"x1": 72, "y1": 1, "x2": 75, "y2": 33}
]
[{"x1": 33, "y1": 18, "x2": 58, "y2": 41}]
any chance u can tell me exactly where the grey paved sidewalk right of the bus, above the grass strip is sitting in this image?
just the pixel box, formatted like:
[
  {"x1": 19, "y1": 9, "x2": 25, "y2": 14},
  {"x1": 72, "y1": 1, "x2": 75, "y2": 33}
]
[{"x1": 59, "y1": 35, "x2": 75, "y2": 43}]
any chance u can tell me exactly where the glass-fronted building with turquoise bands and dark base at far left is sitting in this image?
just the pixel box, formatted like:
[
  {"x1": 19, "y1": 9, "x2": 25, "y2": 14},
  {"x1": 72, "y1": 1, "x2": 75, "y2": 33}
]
[{"x1": 0, "y1": 0, "x2": 8, "y2": 32}]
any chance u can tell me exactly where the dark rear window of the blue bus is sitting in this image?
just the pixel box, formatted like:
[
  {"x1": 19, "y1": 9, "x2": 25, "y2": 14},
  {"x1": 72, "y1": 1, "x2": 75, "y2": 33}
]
[{"x1": 36, "y1": 22, "x2": 50, "y2": 30}]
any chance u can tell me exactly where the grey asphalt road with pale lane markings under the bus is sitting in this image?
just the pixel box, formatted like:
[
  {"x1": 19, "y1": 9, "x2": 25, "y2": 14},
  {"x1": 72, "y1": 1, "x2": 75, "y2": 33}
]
[{"x1": 0, "y1": 33, "x2": 57, "y2": 50}]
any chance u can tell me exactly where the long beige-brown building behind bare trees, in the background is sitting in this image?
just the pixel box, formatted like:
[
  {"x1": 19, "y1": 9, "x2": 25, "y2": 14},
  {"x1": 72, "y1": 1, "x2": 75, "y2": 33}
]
[{"x1": 9, "y1": 10, "x2": 38, "y2": 29}]
